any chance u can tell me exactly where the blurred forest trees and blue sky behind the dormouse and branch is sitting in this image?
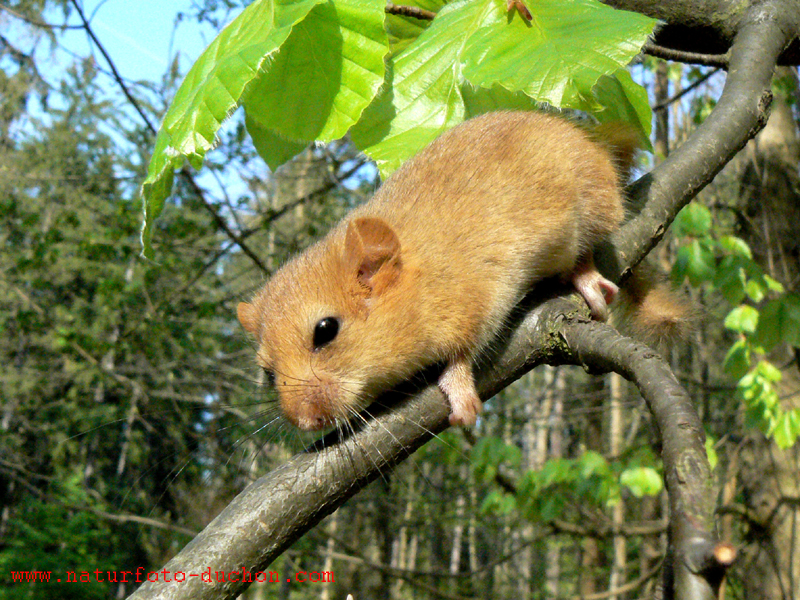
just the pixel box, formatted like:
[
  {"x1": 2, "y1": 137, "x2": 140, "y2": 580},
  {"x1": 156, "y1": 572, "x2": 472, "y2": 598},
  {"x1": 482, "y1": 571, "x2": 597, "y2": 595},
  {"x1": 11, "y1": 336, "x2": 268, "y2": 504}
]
[{"x1": 0, "y1": 1, "x2": 800, "y2": 598}]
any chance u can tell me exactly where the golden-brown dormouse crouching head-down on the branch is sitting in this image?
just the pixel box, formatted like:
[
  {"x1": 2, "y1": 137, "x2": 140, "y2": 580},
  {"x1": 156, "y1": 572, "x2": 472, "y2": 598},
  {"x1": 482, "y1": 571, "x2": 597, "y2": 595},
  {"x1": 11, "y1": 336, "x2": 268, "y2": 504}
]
[{"x1": 238, "y1": 112, "x2": 680, "y2": 430}]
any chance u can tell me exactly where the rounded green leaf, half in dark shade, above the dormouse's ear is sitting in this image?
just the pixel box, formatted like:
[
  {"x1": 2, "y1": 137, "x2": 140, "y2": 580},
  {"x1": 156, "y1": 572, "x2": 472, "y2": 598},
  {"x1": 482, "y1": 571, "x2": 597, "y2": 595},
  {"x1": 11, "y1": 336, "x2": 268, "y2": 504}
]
[{"x1": 243, "y1": 0, "x2": 389, "y2": 142}]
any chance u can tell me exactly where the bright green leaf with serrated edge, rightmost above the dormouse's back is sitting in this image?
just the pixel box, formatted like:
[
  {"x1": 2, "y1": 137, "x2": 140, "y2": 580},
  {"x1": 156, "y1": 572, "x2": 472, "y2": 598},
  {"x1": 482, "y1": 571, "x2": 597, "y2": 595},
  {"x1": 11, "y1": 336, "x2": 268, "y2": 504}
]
[{"x1": 462, "y1": 0, "x2": 655, "y2": 112}]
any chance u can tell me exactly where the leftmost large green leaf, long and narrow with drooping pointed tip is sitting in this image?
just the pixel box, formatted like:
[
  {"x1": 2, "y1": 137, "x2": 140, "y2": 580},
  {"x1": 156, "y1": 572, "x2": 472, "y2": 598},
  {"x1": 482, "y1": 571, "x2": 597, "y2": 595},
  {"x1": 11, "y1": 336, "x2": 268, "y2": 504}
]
[{"x1": 141, "y1": 0, "x2": 323, "y2": 258}]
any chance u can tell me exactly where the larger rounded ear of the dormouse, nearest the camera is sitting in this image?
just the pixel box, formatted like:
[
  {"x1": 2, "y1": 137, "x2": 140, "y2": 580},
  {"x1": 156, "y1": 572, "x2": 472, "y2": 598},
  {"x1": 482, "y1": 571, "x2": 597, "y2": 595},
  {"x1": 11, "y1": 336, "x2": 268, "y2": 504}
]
[{"x1": 344, "y1": 217, "x2": 402, "y2": 295}]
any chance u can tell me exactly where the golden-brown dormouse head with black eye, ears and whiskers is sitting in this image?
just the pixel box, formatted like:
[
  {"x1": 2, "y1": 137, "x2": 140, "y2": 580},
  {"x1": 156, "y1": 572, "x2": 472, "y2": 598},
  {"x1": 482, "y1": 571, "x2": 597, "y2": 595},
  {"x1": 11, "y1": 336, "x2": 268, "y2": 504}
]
[{"x1": 238, "y1": 217, "x2": 418, "y2": 430}]
